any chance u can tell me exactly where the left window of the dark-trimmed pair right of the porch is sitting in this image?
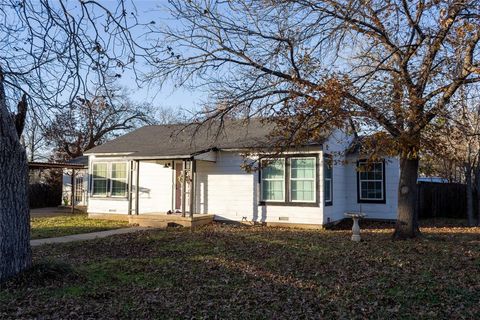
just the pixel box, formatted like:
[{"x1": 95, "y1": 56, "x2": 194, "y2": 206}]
[{"x1": 262, "y1": 159, "x2": 285, "y2": 201}]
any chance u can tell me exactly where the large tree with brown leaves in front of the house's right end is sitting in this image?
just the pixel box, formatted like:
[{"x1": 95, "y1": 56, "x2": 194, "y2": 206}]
[{"x1": 147, "y1": 0, "x2": 480, "y2": 238}]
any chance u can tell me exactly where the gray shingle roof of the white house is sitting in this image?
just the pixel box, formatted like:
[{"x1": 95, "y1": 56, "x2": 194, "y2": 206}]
[{"x1": 85, "y1": 119, "x2": 323, "y2": 157}]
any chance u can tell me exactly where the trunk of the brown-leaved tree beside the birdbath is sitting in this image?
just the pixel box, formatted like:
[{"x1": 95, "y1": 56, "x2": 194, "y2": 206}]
[{"x1": 393, "y1": 156, "x2": 420, "y2": 239}]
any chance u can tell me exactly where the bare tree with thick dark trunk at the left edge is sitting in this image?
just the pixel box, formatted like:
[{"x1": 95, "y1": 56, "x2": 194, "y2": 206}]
[{"x1": 0, "y1": 0, "x2": 145, "y2": 281}]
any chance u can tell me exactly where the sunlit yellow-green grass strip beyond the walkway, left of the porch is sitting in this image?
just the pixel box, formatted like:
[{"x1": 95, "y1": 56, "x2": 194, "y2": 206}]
[{"x1": 30, "y1": 213, "x2": 128, "y2": 239}]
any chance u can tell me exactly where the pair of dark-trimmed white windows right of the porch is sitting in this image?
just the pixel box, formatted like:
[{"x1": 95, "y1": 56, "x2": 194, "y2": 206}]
[{"x1": 260, "y1": 155, "x2": 317, "y2": 205}]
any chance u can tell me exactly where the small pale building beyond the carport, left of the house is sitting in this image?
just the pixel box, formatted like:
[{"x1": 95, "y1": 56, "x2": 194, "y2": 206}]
[{"x1": 61, "y1": 156, "x2": 88, "y2": 207}]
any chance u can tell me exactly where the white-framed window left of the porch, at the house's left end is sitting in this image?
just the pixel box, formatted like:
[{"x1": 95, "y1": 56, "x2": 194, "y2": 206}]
[{"x1": 92, "y1": 162, "x2": 128, "y2": 197}]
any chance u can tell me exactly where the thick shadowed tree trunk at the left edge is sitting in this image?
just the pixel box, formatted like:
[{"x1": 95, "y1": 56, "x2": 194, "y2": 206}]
[{"x1": 0, "y1": 69, "x2": 32, "y2": 282}]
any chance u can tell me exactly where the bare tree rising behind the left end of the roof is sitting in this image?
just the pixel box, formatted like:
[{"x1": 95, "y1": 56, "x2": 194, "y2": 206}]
[{"x1": 45, "y1": 88, "x2": 155, "y2": 160}]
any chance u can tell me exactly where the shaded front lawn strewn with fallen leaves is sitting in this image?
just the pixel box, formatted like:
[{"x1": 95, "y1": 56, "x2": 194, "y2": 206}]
[{"x1": 0, "y1": 225, "x2": 480, "y2": 319}]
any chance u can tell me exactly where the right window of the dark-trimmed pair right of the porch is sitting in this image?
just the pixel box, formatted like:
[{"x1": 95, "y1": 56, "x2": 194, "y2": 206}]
[{"x1": 290, "y1": 158, "x2": 316, "y2": 202}]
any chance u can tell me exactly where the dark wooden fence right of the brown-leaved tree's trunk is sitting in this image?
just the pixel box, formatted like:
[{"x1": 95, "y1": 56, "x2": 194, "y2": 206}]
[{"x1": 418, "y1": 182, "x2": 468, "y2": 219}]
